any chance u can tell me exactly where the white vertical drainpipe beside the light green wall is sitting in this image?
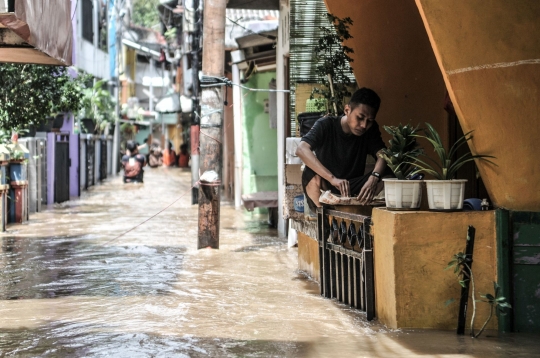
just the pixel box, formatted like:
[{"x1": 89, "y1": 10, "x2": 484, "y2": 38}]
[{"x1": 232, "y1": 64, "x2": 243, "y2": 209}]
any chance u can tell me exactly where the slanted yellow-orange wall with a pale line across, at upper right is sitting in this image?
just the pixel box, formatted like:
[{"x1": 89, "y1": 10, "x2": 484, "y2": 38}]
[{"x1": 416, "y1": 0, "x2": 540, "y2": 211}]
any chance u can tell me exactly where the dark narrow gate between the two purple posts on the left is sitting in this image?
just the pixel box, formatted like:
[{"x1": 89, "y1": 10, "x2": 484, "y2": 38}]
[{"x1": 54, "y1": 134, "x2": 71, "y2": 203}]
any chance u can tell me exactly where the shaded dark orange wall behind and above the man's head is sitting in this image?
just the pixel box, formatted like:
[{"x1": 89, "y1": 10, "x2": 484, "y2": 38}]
[{"x1": 325, "y1": 0, "x2": 448, "y2": 150}]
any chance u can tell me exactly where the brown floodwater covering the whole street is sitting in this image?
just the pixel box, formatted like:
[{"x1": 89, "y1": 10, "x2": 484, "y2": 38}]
[{"x1": 0, "y1": 169, "x2": 540, "y2": 357}]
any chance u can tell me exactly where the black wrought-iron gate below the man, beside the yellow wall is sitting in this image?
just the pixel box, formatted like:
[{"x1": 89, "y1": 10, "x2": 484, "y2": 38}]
[{"x1": 317, "y1": 208, "x2": 375, "y2": 321}]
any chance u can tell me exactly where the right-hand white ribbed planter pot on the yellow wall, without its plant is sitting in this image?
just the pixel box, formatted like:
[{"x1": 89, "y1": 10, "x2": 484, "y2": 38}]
[{"x1": 424, "y1": 179, "x2": 467, "y2": 211}]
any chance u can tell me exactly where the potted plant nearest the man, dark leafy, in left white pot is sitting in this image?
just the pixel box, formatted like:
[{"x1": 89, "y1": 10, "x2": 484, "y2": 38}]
[{"x1": 379, "y1": 124, "x2": 423, "y2": 210}]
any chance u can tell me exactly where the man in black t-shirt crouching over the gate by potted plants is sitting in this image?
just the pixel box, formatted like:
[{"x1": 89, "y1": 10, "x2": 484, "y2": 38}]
[{"x1": 296, "y1": 88, "x2": 386, "y2": 212}]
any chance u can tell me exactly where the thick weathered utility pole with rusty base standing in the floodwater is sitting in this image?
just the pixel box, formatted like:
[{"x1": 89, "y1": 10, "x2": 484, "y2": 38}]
[{"x1": 197, "y1": 0, "x2": 227, "y2": 249}]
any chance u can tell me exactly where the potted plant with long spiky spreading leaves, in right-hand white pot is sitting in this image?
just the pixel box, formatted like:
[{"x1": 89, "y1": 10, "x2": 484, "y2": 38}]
[{"x1": 413, "y1": 123, "x2": 496, "y2": 211}]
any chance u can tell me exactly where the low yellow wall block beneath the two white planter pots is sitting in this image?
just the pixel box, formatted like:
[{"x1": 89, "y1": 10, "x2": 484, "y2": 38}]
[{"x1": 372, "y1": 208, "x2": 497, "y2": 330}]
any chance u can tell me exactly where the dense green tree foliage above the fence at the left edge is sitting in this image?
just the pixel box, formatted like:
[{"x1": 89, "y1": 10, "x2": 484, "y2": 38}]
[{"x1": 0, "y1": 63, "x2": 88, "y2": 131}]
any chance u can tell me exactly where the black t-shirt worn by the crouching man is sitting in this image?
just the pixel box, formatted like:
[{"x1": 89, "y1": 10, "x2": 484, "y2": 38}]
[{"x1": 302, "y1": 116, "x2": 385, "y2": 180}]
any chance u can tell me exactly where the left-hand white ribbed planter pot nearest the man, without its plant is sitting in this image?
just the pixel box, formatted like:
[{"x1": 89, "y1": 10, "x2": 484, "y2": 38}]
[{"x1": 383, "y1": 178, "x2": 424, "y2": 210}]
